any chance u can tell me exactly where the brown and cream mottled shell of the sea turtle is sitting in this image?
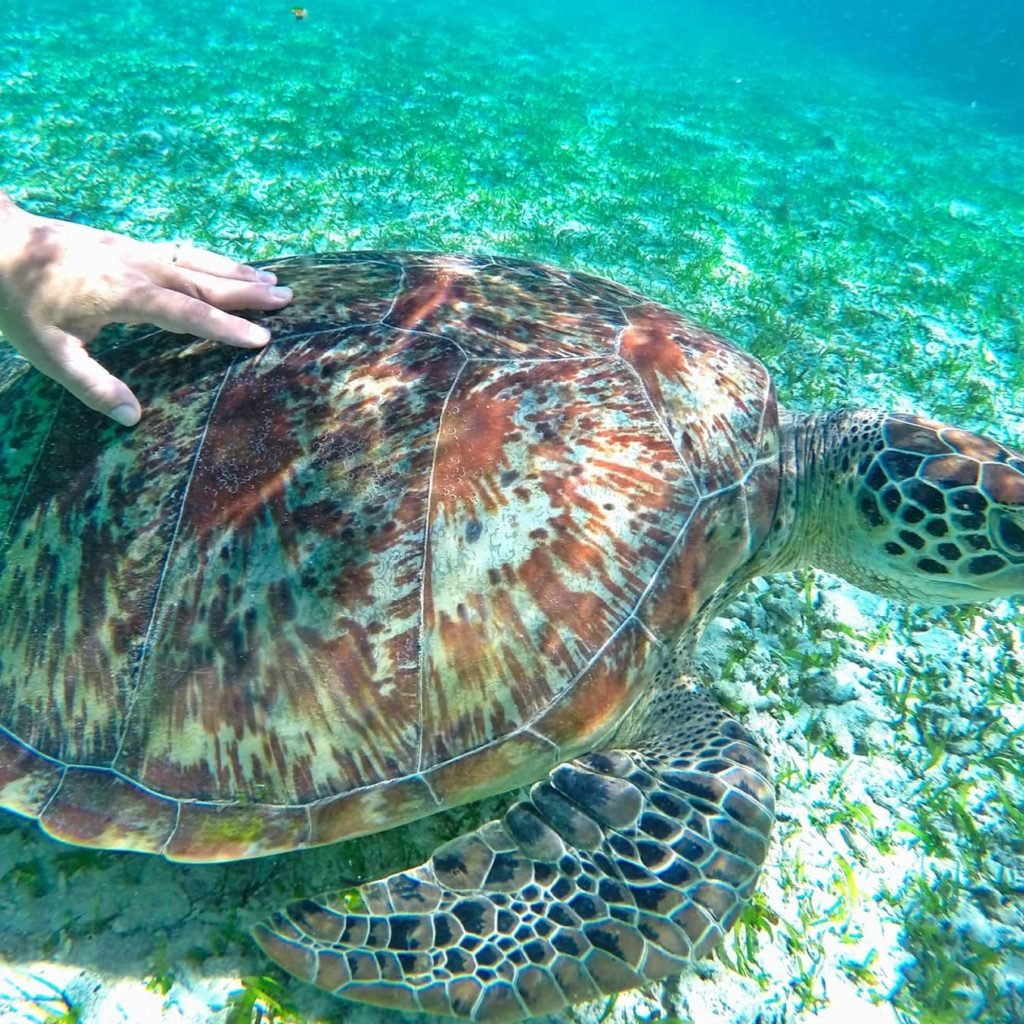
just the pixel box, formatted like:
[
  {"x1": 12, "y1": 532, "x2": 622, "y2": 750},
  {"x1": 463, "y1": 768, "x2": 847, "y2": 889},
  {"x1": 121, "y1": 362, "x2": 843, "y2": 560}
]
[{"x1": 0, "y1": 252, "x2": 778, "y2": 860}]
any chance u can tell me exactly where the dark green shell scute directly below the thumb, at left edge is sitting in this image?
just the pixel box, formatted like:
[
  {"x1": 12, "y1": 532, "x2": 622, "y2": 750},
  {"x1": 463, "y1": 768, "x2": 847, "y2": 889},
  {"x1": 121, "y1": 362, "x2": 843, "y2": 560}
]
[{"x1": 0, "y1": 331, "x2": 230, "y2": 764}]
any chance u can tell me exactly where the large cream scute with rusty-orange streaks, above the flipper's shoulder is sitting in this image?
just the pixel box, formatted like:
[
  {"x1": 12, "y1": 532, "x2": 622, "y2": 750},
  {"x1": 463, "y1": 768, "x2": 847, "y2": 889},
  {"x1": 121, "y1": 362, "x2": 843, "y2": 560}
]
[{"x1": 423, "y1": 360, "x2": 696, "y2": 763}]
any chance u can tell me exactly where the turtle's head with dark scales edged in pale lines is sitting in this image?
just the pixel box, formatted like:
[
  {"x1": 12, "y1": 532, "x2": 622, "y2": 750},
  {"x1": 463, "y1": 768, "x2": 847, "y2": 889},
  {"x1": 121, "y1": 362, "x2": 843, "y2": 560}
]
[{"x1": 810, "y1": 413, "x2": 1024, "y2": 604}]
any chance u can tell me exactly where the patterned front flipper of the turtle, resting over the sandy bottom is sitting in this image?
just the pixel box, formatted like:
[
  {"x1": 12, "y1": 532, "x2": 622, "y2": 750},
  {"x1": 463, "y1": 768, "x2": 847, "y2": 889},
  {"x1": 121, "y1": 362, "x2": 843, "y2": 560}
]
[{"x1": 255, "y1": 688, "x2": 774, "y2": 1021}]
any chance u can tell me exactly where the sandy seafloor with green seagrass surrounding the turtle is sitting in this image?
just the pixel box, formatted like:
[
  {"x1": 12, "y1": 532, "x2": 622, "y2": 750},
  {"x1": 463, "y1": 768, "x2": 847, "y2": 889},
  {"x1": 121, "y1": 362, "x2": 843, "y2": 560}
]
[{"x1": 0, "y1": 0, "x2": 1024, "y2": 1024}]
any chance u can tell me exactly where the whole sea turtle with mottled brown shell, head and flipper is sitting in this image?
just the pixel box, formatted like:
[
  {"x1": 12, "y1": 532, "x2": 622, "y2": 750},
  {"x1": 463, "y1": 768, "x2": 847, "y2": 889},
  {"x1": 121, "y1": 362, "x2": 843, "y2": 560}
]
[{"x1": 0, "y1": 252, "x2": 1024, "y2": 1020}]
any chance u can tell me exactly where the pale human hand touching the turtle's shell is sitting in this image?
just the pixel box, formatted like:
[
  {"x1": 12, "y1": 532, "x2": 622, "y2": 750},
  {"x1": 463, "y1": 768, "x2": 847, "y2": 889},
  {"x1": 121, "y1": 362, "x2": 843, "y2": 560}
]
[{"x1": 0, "y1": 193, "x2": 292, "y2": 426}]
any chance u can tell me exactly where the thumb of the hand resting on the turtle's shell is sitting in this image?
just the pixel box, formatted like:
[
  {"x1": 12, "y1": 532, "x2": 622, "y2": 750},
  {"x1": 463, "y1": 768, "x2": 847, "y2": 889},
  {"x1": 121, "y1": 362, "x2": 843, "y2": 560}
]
[{"x1": 28, "y1": 327, "x2": 142, "y2": 427}]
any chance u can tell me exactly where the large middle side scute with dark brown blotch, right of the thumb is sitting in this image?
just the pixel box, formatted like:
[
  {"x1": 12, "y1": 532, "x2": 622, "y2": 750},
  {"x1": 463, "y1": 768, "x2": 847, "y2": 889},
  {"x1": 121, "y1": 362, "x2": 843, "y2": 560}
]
[{"x1": 118, "y1": 319, "x2": 462, "y2": 804}]
